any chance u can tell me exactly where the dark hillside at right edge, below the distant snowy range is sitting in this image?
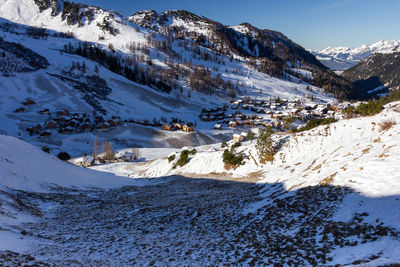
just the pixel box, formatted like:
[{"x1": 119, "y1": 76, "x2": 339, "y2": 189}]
[{"x1": 342, "y1": 52, "x2": 400, "y2": 92}]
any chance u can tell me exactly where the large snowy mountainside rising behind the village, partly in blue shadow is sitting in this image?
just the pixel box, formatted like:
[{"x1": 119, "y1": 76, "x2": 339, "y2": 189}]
[{"x1": 0, "y1": 0, "x2": 355, "y2": 156}]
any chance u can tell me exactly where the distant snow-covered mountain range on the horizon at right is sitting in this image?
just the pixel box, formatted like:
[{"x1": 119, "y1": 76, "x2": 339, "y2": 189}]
[{"x1": 312, "y1": 40, "x2": 400, "y2": 71}]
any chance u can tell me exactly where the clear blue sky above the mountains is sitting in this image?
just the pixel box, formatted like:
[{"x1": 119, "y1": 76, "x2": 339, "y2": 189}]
[{"x1": 77, "y1": 0, "x2": 400, "y2": 49}]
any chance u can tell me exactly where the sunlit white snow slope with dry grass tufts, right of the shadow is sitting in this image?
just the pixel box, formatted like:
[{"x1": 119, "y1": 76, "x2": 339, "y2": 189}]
[{"x1": 93, "y1": 102, "x2": 400, "y2": 200}]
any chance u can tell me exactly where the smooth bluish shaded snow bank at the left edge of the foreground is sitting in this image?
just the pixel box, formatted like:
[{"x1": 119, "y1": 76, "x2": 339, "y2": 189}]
[{"x1": 0, "y1": 135, "x2": 133, "y2": 192}]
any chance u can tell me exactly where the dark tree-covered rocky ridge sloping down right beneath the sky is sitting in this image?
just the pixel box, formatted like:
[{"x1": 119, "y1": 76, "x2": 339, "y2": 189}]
[{"x1": 129, "y1": 10, "x2": 366, "y2": 99}]
